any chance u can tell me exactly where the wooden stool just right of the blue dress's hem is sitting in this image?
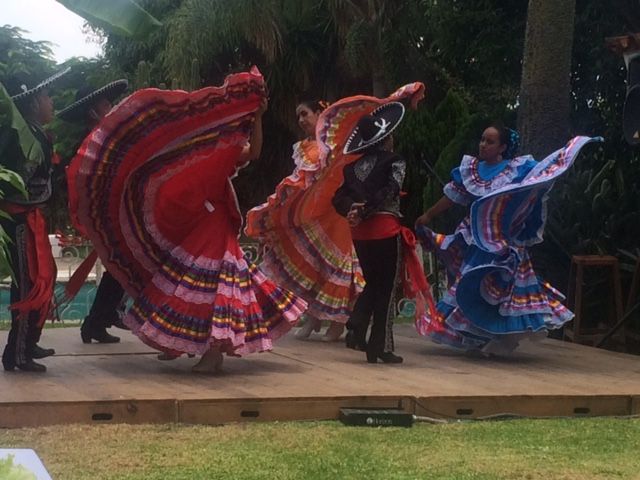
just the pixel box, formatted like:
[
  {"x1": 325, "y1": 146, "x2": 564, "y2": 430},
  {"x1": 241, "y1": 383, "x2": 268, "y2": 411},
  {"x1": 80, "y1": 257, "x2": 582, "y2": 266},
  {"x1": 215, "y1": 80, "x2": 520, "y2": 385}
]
[{"x1": 564, "y1": 255, "x2": 623, "y2": 345}]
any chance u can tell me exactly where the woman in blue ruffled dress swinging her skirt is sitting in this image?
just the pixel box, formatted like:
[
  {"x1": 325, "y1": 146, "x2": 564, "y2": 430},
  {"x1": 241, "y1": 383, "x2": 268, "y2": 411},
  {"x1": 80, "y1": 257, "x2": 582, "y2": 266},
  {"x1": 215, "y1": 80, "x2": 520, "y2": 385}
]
[{"x1": 416, "y1": 125, "x2": 599, "y2": 354}]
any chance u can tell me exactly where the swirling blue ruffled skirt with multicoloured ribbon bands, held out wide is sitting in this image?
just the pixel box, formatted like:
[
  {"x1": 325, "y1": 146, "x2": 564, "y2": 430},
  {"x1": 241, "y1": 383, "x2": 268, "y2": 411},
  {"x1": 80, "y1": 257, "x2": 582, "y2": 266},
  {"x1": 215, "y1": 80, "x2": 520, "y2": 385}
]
[{"x1": 417, "y1": 137, "x2": 600, "y2": 354}]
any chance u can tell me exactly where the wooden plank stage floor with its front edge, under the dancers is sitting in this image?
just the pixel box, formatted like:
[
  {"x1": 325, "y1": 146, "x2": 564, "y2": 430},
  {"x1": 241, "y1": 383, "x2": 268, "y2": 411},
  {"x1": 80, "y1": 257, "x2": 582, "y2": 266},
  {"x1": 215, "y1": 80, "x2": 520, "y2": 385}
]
[{"x1": 0, "y1": 325, "x2": 640, "y2": 428}]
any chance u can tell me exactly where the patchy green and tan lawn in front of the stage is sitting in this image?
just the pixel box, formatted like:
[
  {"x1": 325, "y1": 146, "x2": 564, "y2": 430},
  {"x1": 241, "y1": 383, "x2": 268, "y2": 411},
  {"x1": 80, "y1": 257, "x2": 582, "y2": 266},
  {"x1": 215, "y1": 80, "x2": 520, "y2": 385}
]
[{"x1": 0, "y1": 418, "x2": 640, "y2": 480}]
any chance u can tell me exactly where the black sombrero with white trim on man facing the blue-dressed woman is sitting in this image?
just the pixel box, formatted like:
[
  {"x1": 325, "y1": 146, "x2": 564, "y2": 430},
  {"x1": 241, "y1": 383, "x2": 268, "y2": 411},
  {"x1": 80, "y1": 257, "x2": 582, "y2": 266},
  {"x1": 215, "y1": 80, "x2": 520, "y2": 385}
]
[{"x1": 344, "y1": 102, "x2": 404, "y2": 154}]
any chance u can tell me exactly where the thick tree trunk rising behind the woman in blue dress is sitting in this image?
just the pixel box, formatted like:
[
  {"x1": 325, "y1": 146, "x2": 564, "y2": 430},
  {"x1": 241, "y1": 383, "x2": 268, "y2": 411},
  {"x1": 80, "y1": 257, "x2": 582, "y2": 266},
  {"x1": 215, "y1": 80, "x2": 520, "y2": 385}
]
[{"x1": 518, "y1": 0, "x2": 576, "y2": 159}]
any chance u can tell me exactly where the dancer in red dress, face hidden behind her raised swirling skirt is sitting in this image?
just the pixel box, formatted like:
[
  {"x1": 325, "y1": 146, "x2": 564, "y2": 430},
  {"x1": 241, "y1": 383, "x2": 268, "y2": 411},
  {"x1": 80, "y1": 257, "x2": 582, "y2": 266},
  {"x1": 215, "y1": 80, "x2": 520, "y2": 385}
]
[{"x1": 74, "y1": 69, "x2": 306, "y2": 372}]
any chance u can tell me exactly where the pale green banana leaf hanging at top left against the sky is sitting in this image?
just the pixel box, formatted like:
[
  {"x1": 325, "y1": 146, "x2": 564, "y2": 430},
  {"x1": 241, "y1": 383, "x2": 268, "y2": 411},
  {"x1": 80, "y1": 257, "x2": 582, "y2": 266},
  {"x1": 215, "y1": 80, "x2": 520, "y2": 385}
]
[{"x1": 57, "y1": 0, "x2": 162, "y2": 39}]
